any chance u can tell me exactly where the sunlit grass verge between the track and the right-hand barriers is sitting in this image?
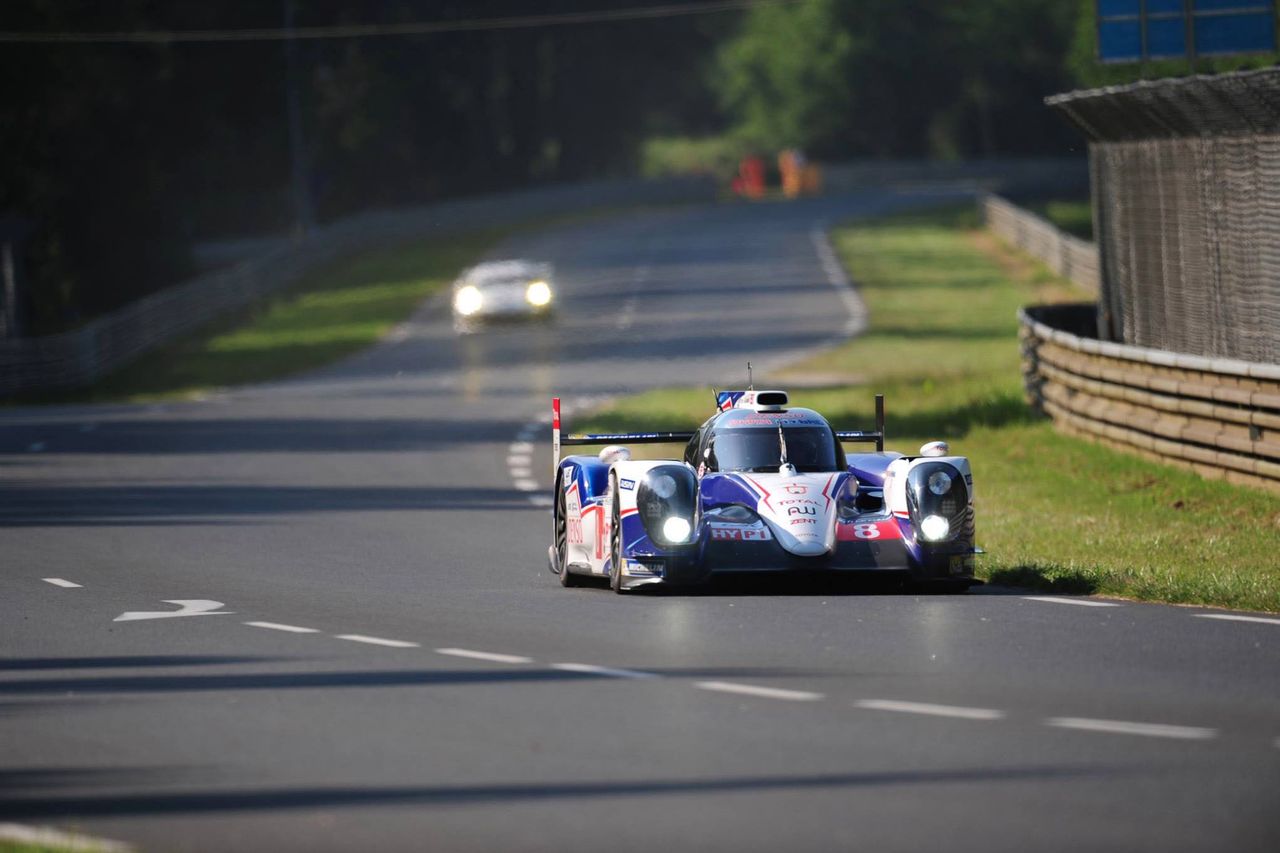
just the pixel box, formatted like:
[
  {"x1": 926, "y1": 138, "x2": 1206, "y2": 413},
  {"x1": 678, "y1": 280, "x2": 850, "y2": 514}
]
[{"x1": 572, "y1": 204, "x2": 1280, "y2": 611}]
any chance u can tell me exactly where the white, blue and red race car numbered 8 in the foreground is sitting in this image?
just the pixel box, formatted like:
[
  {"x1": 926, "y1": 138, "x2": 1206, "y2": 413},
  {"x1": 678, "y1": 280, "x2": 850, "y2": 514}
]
[{"x1": 548, "y1": 389, "x2": 980, "y2": 593}]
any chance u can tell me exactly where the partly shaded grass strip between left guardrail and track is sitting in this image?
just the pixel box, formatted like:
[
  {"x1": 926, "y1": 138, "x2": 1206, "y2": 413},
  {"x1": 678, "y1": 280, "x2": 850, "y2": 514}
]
[{"x1": 9, "y1": 229, "x2": 509, "y2": 403}]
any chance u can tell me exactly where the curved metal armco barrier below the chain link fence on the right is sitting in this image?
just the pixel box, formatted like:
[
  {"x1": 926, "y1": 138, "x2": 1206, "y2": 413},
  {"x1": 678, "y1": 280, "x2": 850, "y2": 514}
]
[{"x1": 1019, "y1": 305, "x2": 1280, "y2": 492}]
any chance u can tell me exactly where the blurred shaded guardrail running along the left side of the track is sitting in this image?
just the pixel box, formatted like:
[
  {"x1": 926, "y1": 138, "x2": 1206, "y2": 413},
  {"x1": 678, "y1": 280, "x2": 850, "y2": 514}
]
[{"x1": 0, "y1": 178, "x2": 718, "y2": 396}]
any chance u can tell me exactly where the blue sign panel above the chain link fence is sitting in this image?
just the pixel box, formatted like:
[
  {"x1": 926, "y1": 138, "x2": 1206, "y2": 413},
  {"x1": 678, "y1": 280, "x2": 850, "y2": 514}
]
[{"x1": 1097, "y1": 0, "x2": 1276, "y2": 63}]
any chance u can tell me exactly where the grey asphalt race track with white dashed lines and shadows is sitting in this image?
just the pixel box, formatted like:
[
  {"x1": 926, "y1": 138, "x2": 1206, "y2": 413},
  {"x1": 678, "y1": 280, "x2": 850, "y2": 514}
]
[{"x1": 0, "y1": 192, "x2": 1280, "y2": 852}]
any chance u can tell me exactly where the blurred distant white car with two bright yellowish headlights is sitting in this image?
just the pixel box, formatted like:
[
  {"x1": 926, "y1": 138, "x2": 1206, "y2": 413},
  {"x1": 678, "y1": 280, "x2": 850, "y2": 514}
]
[{"x1": 453, "y1": 260, "x2": 556, "y2": 334}]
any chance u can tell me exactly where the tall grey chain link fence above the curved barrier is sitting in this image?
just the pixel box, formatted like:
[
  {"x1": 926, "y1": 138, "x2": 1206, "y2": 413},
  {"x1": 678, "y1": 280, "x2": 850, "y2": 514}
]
[{"x1": 1047, "y1": 68, "x2": 1280, "y2": 364}]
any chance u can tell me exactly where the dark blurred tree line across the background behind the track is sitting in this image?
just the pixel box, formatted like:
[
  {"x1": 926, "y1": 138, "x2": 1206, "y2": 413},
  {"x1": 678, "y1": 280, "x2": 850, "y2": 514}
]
[{"x1": 0, "y1": 0, "x2": 1198, "y2": 333}]
